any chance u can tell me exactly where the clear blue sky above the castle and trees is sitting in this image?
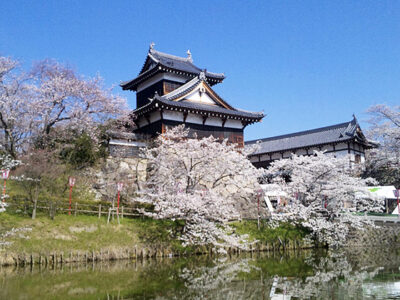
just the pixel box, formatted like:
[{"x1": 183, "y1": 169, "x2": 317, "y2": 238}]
[{"x1": 0, "y1": 0, "x2": 400, "y2": 140}]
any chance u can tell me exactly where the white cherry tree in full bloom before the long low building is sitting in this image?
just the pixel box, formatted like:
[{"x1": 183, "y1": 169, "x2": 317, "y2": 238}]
[{"x1": 264, "y1": 152, "x2": 383, "y2": 246}]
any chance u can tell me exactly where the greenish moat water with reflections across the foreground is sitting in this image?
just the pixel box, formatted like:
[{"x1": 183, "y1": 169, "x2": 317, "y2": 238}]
[{"x1": 0, "y1": 248, "x2": 400, "y2": 300}]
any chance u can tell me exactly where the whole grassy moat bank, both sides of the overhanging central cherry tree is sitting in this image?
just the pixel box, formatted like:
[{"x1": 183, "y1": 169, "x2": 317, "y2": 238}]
[{"x1": 0, "y1": 212, "x2": 306, "y2": 261}]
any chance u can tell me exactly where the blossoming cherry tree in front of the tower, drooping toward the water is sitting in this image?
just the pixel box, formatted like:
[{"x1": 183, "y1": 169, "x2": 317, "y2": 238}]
[{"x1": 142, "y1": 126, "x2": 262, "y2": 246}]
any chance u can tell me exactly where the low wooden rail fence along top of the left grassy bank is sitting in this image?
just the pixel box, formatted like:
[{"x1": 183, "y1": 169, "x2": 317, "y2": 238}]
[{"x1": 2, "y1": 197, "x2": 151, "y2": 218}]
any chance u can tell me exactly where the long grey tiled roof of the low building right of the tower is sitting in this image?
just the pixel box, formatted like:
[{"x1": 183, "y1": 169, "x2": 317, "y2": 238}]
[{"x1": 245, "y1": 116, "x2": 376, "y2": 154}]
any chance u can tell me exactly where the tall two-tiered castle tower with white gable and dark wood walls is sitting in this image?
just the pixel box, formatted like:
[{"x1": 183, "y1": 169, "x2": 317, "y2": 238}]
[{"x1": 121, "y1": 44, "x2": 264, "y2": 146}]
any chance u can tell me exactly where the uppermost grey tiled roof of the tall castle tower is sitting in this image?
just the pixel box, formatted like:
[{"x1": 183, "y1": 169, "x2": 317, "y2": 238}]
[{"x1": 120, "y1": 45, "x2": 225, "y2": 90}]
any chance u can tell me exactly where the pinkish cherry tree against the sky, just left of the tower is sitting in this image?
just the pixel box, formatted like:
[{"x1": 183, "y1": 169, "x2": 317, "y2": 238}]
[{"x1": 31, "y1": 60, "x2": 128, "y2": 139}]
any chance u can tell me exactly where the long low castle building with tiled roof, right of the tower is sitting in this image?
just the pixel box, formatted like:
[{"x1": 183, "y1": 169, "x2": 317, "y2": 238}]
[{"x1": 245, "y1": 116, "x2": 377, "y2": 168}]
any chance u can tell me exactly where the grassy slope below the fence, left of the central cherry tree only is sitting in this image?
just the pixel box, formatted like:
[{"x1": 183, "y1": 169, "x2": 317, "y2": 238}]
[{"x1": 0, "y1": 213, "x2": 181, "y2": 253}]
